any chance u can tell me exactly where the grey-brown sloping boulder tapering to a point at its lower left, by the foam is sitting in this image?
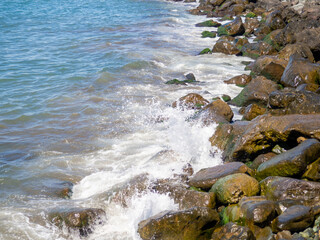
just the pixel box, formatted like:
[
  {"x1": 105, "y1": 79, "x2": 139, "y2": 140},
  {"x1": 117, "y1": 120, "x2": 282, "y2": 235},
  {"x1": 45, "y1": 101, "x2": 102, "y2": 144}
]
[{"x1": 230, "y1": 76, "x2": 279, "y2": 107}]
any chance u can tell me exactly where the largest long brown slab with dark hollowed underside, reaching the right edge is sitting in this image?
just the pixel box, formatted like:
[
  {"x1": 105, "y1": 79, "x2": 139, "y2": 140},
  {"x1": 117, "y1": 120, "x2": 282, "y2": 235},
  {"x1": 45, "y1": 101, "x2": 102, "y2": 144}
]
[{"x1": 218, "y1": 114, "x2": 320, "y2": 161}]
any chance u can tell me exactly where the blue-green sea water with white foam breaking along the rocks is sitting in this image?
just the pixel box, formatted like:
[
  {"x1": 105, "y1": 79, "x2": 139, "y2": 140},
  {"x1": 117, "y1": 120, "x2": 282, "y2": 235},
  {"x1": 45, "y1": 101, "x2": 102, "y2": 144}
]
[{"x1": 0, "y1": 0, "x2": 248, "y2": 240}]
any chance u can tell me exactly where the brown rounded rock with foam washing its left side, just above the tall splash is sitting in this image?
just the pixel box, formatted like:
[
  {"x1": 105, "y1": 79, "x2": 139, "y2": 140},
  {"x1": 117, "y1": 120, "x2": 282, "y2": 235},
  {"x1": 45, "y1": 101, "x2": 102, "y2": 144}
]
[{"x1": 195, "y1": 99, "x2": 233, "y2": 125}]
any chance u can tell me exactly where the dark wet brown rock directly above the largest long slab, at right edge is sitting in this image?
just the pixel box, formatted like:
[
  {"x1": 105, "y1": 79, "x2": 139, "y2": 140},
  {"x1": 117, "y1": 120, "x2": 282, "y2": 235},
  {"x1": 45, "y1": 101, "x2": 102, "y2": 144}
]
[{"x1": 268, "y1": 89, "x2": 320, "y2": 115}]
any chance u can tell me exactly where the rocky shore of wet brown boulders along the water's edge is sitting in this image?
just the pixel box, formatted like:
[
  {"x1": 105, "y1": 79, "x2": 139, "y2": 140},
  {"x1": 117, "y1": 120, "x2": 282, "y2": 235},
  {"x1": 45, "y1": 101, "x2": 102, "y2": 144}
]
[{"x1": 45, "y1": 0, "x2": 320, "y2": 240}]
